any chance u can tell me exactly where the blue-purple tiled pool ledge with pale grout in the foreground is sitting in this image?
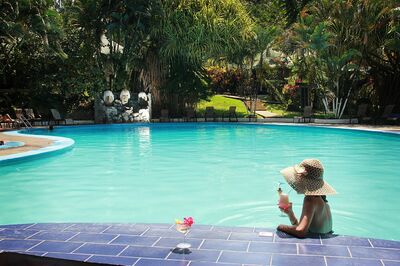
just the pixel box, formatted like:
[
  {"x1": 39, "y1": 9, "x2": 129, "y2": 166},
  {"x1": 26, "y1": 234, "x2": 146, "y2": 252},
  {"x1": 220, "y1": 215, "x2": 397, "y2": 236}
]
[{"x1": 0, "y1": 223, "x2": 400, "y2": 266}]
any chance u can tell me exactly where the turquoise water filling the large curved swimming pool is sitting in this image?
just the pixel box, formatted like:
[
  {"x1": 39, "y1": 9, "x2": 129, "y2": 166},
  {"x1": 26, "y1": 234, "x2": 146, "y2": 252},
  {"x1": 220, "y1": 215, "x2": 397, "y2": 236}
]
[{"x1": 0, "y1": 123, "x2": 400, "y2": 240}]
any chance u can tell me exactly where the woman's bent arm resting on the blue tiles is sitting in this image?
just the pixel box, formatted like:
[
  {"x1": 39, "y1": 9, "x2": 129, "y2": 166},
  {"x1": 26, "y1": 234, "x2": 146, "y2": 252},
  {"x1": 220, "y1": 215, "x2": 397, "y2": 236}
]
[{"x1": 278, "y1": 196, "x2": 315, "y2": 237}]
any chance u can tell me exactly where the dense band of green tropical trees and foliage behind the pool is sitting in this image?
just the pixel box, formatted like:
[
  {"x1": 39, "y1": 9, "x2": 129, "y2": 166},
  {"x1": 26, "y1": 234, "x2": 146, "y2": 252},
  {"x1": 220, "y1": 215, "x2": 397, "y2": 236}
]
[{"x1": 0, "y1": 0, "x2": 400, "y2": 117}]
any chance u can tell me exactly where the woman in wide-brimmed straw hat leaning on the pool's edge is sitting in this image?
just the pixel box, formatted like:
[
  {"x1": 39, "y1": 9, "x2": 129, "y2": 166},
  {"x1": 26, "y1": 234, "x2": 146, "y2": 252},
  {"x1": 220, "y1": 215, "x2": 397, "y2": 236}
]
[{"x1": 278, "y1": 159, "x2": 336, "y2": 237}]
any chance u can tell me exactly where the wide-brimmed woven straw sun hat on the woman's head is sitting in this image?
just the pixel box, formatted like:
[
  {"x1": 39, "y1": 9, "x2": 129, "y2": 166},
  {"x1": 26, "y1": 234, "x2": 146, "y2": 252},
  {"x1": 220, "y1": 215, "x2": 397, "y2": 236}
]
[{"x1": 281, "y1": 159, "x2": 336, "y2": 196}]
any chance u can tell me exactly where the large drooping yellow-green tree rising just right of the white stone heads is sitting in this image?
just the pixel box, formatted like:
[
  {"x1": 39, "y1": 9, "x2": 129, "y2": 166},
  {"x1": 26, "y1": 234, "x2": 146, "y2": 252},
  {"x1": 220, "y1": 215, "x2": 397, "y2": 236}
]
[{"x1": 143, "y1": 0, "x2": 254, "y2": 112}]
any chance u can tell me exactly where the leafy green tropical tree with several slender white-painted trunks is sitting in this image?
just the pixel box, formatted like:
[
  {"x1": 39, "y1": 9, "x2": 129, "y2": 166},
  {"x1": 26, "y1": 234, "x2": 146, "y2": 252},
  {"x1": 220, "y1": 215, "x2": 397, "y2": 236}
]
[{"x1": 293, "y1": 0, "x2": 362, "y2": 118}]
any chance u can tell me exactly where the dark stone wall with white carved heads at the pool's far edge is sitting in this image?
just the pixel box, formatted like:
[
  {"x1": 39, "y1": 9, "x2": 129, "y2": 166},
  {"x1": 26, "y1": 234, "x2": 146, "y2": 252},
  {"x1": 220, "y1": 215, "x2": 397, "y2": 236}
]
[{"x1": 95, "y1": 90, "x2": 151, "y2": 123}]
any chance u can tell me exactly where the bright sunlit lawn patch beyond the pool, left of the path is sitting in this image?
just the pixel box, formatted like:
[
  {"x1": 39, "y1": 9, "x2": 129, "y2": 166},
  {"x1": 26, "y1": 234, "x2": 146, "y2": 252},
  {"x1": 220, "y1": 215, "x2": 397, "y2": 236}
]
[{"x1": 196, "y1": 95, "x2": 248, "y2": 117}]
